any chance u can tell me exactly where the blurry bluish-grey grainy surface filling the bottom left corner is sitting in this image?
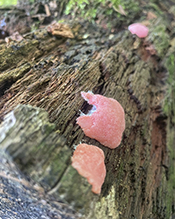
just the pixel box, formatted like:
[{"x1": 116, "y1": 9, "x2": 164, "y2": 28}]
[{"x1": 0, "y1": 149, "x2": 80, "y2": 219}]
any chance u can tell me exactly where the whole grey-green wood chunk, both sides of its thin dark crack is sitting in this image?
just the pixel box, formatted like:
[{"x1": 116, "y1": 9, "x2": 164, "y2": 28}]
[{"x1": 0, "y1": 105, "x2": 91, "y2": 212}]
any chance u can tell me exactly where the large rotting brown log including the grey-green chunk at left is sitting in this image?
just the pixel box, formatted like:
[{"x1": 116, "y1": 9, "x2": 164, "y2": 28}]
[{"x1": 0, "y1": 2, "x2": 175, "y2": 219}]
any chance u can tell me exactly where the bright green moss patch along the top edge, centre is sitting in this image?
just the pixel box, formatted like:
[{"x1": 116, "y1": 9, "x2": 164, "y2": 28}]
[{"x1": 65, "y1": 0, "x2": 140, "y2": 22}]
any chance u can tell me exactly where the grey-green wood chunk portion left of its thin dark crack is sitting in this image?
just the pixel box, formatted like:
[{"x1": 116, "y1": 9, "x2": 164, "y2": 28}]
[{"x1": 0, "y1": 105, "x2": 71, "y2": 188}]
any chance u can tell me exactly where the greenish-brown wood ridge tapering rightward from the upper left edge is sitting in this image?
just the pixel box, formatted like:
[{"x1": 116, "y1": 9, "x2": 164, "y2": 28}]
[{"x1": 0, "y1": 29, "x2": 65, "y2": 71}]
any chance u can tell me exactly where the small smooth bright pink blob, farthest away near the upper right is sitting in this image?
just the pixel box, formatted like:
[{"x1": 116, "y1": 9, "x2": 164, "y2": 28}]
[{"x1": 128, "y1": 23, "x2": 149, "y2": 38}]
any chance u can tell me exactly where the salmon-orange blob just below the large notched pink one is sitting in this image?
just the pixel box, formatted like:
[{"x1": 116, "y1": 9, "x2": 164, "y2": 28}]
[{"x1": 72, "y1": 144, "x2": 106, "y2": 194}]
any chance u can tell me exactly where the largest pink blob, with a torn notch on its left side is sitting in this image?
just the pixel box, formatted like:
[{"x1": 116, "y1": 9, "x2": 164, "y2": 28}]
[{"x1": 77, "y1": 92, "x2": 125, "y2": 149}]
